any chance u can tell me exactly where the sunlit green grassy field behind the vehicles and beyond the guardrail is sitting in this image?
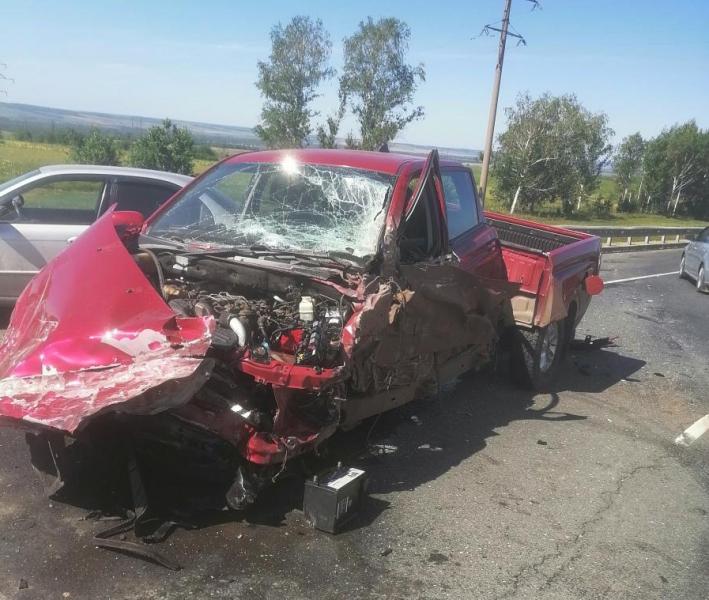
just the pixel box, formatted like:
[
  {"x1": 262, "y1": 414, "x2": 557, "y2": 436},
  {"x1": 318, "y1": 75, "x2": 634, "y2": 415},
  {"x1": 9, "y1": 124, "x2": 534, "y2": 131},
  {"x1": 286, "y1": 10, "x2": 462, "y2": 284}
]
[{"x1": 0, "y1": 135, "x2": 706, "y2": 227}]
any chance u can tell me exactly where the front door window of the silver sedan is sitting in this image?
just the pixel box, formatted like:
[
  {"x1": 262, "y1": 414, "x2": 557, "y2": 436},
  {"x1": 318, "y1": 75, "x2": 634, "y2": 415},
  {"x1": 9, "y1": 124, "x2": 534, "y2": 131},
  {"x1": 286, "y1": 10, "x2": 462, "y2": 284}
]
[{"x1": 11, "y1": 179, "x2": 105, "y2": 225}]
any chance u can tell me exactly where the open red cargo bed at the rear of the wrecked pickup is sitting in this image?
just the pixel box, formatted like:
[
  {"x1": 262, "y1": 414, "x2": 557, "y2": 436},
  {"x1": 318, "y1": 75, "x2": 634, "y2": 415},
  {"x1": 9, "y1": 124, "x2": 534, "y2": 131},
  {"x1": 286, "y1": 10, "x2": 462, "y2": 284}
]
[{"x1": 485, "y1": 212, "x2": 601, "y2": 328}]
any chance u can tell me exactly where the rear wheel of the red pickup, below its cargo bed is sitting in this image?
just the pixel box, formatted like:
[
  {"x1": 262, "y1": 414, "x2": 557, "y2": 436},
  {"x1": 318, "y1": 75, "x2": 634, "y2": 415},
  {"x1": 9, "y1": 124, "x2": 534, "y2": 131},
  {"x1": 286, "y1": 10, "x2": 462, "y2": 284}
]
[{"x1": 512, "y1": 320, "x2": 567, "y2": 391}]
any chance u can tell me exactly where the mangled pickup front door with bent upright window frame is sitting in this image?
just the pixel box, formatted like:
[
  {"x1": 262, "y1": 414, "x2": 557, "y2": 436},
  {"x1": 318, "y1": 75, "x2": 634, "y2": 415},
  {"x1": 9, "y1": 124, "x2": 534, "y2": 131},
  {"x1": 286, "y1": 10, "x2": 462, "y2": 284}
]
[{"x1": 388, "y1": 151, "x2": 505, "y2": 382}]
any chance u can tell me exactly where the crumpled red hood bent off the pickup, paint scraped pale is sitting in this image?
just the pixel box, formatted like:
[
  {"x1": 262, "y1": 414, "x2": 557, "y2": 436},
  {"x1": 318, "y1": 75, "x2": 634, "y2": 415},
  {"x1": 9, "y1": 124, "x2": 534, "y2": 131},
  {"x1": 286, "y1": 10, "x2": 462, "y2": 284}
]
[{"x1": 0, "y1": 211, "x2": 214, "y2": 433}]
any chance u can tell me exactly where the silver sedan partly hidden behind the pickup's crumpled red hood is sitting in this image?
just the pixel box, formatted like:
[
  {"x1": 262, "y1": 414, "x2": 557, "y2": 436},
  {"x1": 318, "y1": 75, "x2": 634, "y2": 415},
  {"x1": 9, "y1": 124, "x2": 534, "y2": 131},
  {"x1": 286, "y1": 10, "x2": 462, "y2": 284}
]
[{"x1": 0, "y1": 165, "x2": 192, "y2": 306}]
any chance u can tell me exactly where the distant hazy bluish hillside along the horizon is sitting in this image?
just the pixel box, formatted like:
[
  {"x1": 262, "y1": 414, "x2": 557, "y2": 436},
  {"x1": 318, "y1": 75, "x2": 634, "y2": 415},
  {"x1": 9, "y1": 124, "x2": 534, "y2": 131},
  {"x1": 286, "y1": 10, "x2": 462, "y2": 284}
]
[{"x1": 0, "y1": 102, "x2": 480, "y2": 162}]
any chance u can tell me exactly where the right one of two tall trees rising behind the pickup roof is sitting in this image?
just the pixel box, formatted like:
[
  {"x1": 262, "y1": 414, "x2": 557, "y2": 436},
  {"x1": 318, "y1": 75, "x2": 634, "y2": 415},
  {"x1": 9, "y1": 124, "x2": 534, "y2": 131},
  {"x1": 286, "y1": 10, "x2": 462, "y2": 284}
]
[{"x1": 340, "y1": 17, "x2": 426, "y2": 150}]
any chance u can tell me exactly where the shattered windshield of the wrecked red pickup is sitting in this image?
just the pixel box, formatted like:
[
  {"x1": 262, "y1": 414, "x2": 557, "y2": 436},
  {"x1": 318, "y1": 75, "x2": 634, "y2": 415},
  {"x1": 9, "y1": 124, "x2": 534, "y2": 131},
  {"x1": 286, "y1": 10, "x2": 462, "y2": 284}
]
[{"x1": 148, "y1": 156, "x2": 394, "y2": 258}]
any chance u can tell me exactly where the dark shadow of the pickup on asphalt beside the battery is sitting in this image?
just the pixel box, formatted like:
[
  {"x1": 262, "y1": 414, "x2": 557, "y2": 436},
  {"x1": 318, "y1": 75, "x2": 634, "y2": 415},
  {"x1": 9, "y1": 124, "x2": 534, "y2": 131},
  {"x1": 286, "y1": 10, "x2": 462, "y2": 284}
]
[{"x1": 290, "y1": 349, "x2": 645, "y2": 494}]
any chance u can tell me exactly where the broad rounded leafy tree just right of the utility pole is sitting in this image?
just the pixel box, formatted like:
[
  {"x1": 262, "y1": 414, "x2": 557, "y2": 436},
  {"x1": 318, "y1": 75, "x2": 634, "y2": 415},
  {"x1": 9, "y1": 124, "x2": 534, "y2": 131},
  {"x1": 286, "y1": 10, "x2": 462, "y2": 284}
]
[{"x1": 493, "y1": 94, "x2": 613, "y2": 214}]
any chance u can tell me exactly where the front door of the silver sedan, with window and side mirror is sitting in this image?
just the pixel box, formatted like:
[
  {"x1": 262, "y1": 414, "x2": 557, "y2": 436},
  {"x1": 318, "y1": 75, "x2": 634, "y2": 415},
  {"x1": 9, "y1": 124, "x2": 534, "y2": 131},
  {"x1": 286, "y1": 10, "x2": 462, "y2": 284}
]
[{"x1": 0, "y1": 176, "x2": 107, "y2": 305}]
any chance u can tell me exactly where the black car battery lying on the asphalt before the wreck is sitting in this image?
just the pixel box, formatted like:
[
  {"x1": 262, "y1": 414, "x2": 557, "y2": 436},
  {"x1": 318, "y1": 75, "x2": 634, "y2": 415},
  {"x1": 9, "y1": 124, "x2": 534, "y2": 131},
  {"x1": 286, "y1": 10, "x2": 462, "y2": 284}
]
[{"x1": 303, "y1": 465, "x2": 367, "y2": 533}]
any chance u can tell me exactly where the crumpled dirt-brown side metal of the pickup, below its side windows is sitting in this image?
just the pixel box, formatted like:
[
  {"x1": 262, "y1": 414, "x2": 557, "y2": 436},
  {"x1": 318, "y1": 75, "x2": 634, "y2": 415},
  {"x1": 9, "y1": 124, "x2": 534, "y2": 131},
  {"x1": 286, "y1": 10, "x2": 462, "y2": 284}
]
[{"x1": 350, "y1": 262, "x2": 514, "y2": 392}]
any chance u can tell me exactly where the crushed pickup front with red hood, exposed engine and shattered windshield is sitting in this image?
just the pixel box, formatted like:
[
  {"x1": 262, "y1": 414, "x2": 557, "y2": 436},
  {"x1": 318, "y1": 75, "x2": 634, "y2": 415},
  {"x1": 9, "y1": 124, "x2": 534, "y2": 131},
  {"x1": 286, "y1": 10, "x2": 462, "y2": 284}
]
[{"x1": 0, "y1": 152, "x2": 510, "y2": 509}]
